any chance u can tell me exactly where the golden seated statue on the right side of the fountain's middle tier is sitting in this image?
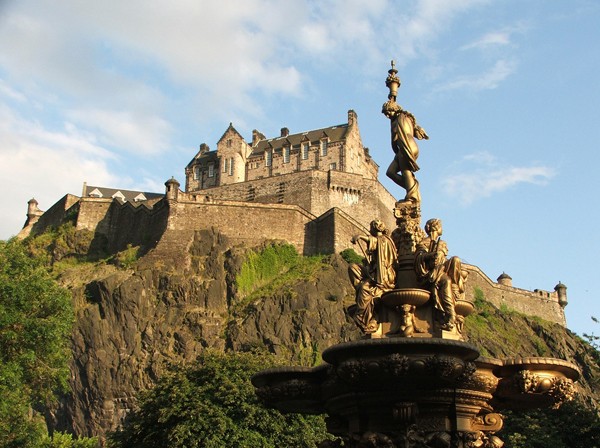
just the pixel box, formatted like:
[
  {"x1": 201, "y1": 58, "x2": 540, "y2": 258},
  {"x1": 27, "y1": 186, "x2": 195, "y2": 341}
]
[{"x1": 415, "y1": 218, "x2": 467, "y2": 332}]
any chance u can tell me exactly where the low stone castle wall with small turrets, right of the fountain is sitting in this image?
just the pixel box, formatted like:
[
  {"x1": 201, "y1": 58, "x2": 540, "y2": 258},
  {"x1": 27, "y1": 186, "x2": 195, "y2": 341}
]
[{"x1": 463, "y1": 264, "x2": 567, "y2": 327}]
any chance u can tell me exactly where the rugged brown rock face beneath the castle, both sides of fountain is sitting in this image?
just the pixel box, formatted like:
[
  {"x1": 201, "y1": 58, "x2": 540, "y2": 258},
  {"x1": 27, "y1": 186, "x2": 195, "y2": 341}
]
[{"x1": 48, "y1": 229, "x2": 600, "y2": 436}]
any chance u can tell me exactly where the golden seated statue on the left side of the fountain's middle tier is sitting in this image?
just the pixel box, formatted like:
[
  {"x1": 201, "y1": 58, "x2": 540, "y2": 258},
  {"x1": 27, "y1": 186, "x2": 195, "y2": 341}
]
[{"x1": 348, "y1": 219, "x2": 397, "y2": 333}]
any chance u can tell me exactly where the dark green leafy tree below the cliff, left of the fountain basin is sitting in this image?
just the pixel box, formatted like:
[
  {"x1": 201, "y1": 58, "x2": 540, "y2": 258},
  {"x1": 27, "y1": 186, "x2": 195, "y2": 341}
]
[{"x1": 109, "y1": 350, "x2": 327, "y2": 448}]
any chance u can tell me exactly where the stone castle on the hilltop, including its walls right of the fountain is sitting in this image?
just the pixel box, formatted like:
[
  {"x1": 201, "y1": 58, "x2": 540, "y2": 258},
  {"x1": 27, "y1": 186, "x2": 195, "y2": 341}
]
[{"x1": 18, "y1": 110, "x2": 567, "y2": 325}]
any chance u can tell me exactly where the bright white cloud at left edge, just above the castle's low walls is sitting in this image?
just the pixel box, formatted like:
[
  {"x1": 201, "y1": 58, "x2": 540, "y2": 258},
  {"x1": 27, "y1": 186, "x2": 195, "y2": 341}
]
[{"x1": 0, "y1": 107, "x2": 123, "y2": 239}]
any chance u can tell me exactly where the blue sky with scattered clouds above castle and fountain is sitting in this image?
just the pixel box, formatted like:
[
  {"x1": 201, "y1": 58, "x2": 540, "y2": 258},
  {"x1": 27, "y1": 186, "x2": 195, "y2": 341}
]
[{"x1": 0, "y1": 0, "x2": 600, "y2": 335}]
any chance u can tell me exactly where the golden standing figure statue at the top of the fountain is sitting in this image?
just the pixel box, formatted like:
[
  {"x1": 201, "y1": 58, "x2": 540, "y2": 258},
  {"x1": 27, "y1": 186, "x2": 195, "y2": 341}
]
[{"x1": 381, "y1": 98, "x2": 429, "y2": 203}]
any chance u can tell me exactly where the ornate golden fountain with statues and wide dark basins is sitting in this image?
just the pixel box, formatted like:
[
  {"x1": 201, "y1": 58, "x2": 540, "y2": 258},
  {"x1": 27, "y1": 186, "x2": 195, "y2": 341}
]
[{"x1": 252, "y1": 61, "x2": 579, "y2": 448}]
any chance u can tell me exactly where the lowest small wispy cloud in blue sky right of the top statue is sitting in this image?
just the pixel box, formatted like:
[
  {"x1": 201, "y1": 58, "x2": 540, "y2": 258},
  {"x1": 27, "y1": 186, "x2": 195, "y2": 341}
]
[{"x1": 442, "y1": 152, "x2": 556, "y2": 206}]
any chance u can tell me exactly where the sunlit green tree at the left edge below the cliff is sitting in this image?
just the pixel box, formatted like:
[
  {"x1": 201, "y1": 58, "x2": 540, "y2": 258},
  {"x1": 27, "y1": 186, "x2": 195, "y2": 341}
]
[{"x1": 0, "y1": 240, "x2": 95, "y2": 448}]
